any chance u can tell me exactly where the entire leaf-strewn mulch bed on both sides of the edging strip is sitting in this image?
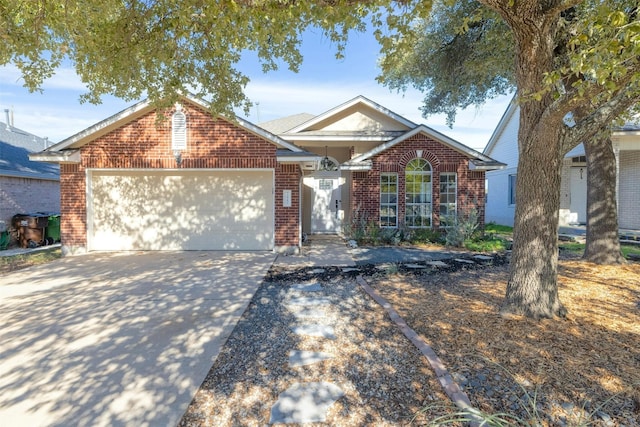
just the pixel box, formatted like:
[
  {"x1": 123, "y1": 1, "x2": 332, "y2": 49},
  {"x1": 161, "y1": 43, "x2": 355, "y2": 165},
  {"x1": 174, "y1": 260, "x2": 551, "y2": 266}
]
[{"x1": 180, "y1": 254, "x2": 640, "y2": 427}]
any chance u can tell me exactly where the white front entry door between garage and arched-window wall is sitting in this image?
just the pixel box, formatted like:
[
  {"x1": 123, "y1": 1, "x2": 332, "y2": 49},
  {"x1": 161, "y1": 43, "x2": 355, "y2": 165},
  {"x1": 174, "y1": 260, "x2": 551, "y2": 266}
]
[{"x1": 311, "y1": 172, "x2": 344, "y2": 234}]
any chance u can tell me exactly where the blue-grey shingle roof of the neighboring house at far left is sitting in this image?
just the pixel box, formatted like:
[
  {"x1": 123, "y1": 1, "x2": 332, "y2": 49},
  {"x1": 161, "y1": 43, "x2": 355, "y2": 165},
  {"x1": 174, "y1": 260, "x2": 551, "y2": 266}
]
[{"x1": 0, "y1": 123, "x2": 60, "y2": 181}]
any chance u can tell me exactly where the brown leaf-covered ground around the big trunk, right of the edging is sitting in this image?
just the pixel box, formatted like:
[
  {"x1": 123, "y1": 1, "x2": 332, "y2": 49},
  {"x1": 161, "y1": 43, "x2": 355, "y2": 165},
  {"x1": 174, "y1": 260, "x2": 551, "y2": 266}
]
[{"x1": 369, "y1": 260, "x2": 640, "y2": 426}]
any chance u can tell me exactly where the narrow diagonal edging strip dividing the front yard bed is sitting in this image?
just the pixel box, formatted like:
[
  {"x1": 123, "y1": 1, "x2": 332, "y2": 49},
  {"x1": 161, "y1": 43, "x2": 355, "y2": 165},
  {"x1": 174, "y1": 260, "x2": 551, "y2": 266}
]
[{"x1": 356, "y1": 276, "x2": 478, "y2": 425}]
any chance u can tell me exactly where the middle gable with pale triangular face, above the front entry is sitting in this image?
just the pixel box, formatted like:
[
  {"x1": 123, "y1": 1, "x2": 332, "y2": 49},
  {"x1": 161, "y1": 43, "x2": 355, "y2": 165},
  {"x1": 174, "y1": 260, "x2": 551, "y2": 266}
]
[{"x1": 280, "y1": 95, "x2": 416, "y2": 141}]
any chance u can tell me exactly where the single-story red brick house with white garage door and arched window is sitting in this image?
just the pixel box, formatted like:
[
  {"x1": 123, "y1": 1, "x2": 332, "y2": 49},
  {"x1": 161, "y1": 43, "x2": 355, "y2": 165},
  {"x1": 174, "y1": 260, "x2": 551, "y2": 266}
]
[{"x1": 31, "y1": 97, "x2": 502, "y2": 253}]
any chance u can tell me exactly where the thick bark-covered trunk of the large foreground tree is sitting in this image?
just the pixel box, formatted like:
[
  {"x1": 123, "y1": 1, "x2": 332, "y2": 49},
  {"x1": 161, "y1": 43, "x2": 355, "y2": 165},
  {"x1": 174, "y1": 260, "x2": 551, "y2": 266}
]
[{"x1": 498, "y1": 0, "x2": 566, "y2": 318}]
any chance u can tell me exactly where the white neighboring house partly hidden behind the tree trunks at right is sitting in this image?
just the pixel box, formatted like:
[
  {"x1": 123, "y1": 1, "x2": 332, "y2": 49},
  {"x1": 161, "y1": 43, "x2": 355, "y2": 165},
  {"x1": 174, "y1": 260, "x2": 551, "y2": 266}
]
[{"x1": 484, "y1": 100, "x2": 640, "y2": 229}]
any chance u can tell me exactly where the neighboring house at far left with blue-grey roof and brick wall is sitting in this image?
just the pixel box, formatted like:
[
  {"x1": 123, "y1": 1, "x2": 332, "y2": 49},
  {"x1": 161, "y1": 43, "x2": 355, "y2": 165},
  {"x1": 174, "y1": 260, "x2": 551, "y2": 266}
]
[{"x1": 0, "y1": 113, "x2": 60, "y2": 228}]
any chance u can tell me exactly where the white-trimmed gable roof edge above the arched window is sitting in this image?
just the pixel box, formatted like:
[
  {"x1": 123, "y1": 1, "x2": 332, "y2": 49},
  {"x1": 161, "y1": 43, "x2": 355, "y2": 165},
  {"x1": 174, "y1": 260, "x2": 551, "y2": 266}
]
[{"x1": 341, "y1": 125, "x2": 506, "y2": 170}]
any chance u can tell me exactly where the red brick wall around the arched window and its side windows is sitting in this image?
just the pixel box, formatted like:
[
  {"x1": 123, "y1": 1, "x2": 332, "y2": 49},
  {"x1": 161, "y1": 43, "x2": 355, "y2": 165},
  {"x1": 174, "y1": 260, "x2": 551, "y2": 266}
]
[{"x1": 351, "y1": 134, "x2": 485, "y2": 228}]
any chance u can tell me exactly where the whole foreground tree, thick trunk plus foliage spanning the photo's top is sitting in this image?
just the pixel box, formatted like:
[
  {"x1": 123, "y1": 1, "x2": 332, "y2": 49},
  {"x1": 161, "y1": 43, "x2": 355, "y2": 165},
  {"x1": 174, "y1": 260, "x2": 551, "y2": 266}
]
[{"x1": 5, "y1": 0, "x2": 640, "y2": 317}]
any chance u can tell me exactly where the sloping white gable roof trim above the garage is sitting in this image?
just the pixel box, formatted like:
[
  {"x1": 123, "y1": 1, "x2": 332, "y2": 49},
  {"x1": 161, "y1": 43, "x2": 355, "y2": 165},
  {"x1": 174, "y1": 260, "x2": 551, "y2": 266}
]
[{"x1": 29, "y1": 95, "x2": 309, "y2": 163}]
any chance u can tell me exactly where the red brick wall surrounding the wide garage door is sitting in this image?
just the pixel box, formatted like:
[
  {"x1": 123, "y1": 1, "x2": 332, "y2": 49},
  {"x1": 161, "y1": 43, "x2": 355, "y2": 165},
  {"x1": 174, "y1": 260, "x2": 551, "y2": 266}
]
[{"x1": 61, "y1": 100, "x2": 300, "y2": 252}]
